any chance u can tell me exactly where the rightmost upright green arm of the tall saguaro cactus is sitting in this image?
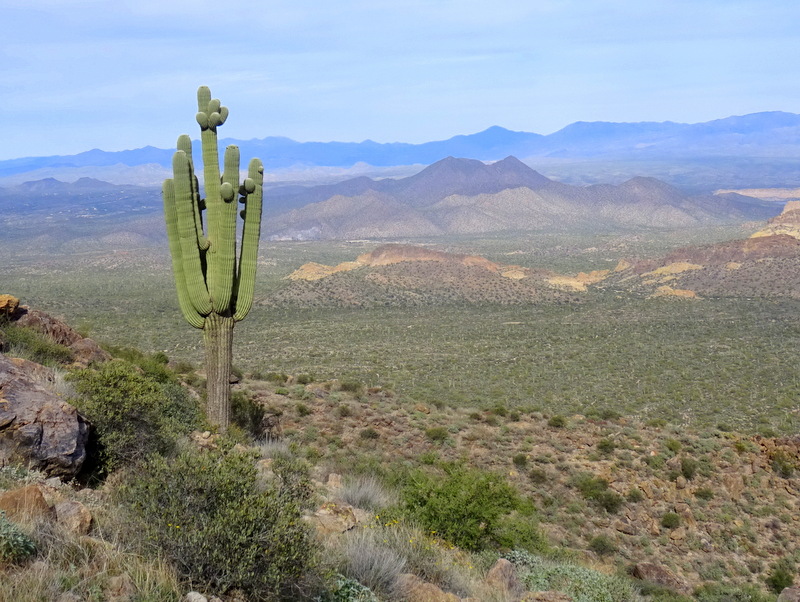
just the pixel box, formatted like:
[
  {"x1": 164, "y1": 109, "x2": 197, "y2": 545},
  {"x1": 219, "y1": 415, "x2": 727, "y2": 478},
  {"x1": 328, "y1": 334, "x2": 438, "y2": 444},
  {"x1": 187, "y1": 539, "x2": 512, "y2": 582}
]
[{"x1": 233, "y1": 159, "x2": 264, "y2": 322}]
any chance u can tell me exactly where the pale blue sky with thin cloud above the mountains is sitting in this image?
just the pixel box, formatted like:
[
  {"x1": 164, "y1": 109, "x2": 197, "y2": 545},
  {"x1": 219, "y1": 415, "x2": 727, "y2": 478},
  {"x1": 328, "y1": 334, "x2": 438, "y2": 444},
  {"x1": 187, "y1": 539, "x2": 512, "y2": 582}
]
[{"x1": 0, "y1": 0, "x2": 800, "y2": 160}]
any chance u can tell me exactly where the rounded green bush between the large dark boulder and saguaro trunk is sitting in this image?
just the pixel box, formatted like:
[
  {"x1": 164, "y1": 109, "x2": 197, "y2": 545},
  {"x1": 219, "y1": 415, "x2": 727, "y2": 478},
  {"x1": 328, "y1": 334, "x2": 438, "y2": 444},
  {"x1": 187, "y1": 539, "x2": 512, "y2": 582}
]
[{"x1": 68, "y1": 361, "x2": 201, "y2": 475}]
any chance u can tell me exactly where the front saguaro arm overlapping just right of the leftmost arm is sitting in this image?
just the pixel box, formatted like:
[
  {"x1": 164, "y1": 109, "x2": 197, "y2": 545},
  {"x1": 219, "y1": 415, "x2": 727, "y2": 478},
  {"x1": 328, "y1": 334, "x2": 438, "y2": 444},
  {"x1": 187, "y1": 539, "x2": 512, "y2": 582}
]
[{"x1": 172, "y1": 151, "x2": 212, "y2": 316}]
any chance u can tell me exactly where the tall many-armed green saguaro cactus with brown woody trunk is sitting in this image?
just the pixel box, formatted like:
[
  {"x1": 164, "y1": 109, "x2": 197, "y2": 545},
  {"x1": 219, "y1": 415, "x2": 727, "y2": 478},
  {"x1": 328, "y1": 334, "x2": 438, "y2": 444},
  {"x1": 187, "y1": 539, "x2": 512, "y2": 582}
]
[{"x1": 162, "y1": 86, "x2": 264, "y2": 429}]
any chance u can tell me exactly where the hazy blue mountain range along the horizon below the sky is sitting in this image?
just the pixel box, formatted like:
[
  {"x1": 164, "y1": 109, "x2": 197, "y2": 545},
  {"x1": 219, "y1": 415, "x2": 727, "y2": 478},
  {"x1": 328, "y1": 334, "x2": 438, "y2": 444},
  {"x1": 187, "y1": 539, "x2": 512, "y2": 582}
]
[{"x1": 0, "y1": 111, "x2": 800, "y2": 187}]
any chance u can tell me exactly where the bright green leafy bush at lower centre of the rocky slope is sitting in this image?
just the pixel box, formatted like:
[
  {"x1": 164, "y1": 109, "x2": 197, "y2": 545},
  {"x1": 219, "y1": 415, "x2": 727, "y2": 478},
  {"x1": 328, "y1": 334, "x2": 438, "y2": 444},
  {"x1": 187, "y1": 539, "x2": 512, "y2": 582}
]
[{"x1": 402, "y1": 465, "x2": 521, "y2": 550}]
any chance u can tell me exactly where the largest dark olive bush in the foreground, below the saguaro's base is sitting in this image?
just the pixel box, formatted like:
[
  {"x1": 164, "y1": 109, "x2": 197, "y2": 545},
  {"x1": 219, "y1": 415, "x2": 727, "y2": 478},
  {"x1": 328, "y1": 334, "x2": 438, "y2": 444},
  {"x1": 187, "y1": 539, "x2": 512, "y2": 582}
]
[{"x1": 116, "y1": 450, "x2": 316, "y2": 600}]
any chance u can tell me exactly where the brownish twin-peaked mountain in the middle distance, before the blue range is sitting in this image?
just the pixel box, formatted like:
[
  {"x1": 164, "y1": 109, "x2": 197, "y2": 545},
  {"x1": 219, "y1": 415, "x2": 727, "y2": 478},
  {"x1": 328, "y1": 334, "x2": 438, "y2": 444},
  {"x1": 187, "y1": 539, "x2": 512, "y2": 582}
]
[{"x1": 264, "y1": 157, "x2": 780, "y2": 240}]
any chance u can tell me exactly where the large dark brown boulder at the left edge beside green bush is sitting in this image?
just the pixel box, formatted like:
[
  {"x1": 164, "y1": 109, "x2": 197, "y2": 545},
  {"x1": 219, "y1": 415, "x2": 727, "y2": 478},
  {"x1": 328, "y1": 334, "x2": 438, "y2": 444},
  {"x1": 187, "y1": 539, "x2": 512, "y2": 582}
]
[{"x1": 0, "y1": 356, "x2": 89, "y2": 478}]
